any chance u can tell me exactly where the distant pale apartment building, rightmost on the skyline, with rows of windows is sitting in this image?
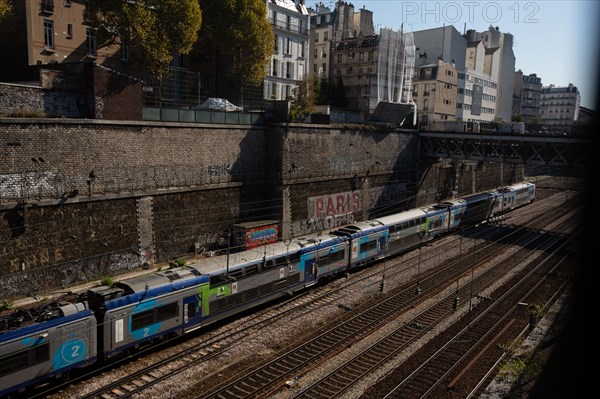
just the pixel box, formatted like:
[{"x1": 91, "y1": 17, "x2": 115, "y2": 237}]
[{"x1": 540, "y1": 83, "x2": 581, "y2": 133}]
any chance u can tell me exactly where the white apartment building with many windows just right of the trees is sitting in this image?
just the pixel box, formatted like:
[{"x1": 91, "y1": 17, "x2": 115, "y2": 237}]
[{"x1": 263, "y1": 0, "x2": 309, "y2": 100}]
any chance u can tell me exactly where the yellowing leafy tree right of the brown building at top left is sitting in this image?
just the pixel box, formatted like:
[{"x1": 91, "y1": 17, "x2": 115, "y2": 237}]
[{"x1": 89, "y1": 0, "x2": 202, "y2": 77}]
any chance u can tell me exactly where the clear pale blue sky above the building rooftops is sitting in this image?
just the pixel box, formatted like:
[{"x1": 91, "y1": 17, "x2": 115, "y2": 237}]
[{"x1": 316, "y1": 0, "x2": 600, "y2": 110}]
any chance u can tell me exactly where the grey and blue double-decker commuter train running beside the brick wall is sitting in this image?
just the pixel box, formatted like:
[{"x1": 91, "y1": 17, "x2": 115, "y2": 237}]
[{"x1": 0, "y1": 183, "x2": 535, "y2": 396}]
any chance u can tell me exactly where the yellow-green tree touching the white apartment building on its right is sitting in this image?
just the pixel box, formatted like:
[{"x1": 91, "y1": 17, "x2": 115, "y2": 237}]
[{"x1": 202, "y1": 0, "x2": 275, "y2": 104}]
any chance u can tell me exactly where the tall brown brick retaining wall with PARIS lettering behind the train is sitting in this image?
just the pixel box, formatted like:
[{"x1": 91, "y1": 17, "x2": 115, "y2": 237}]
[{"x1": 0, "y1": 119, "x2": 518, "y2": 300}]
